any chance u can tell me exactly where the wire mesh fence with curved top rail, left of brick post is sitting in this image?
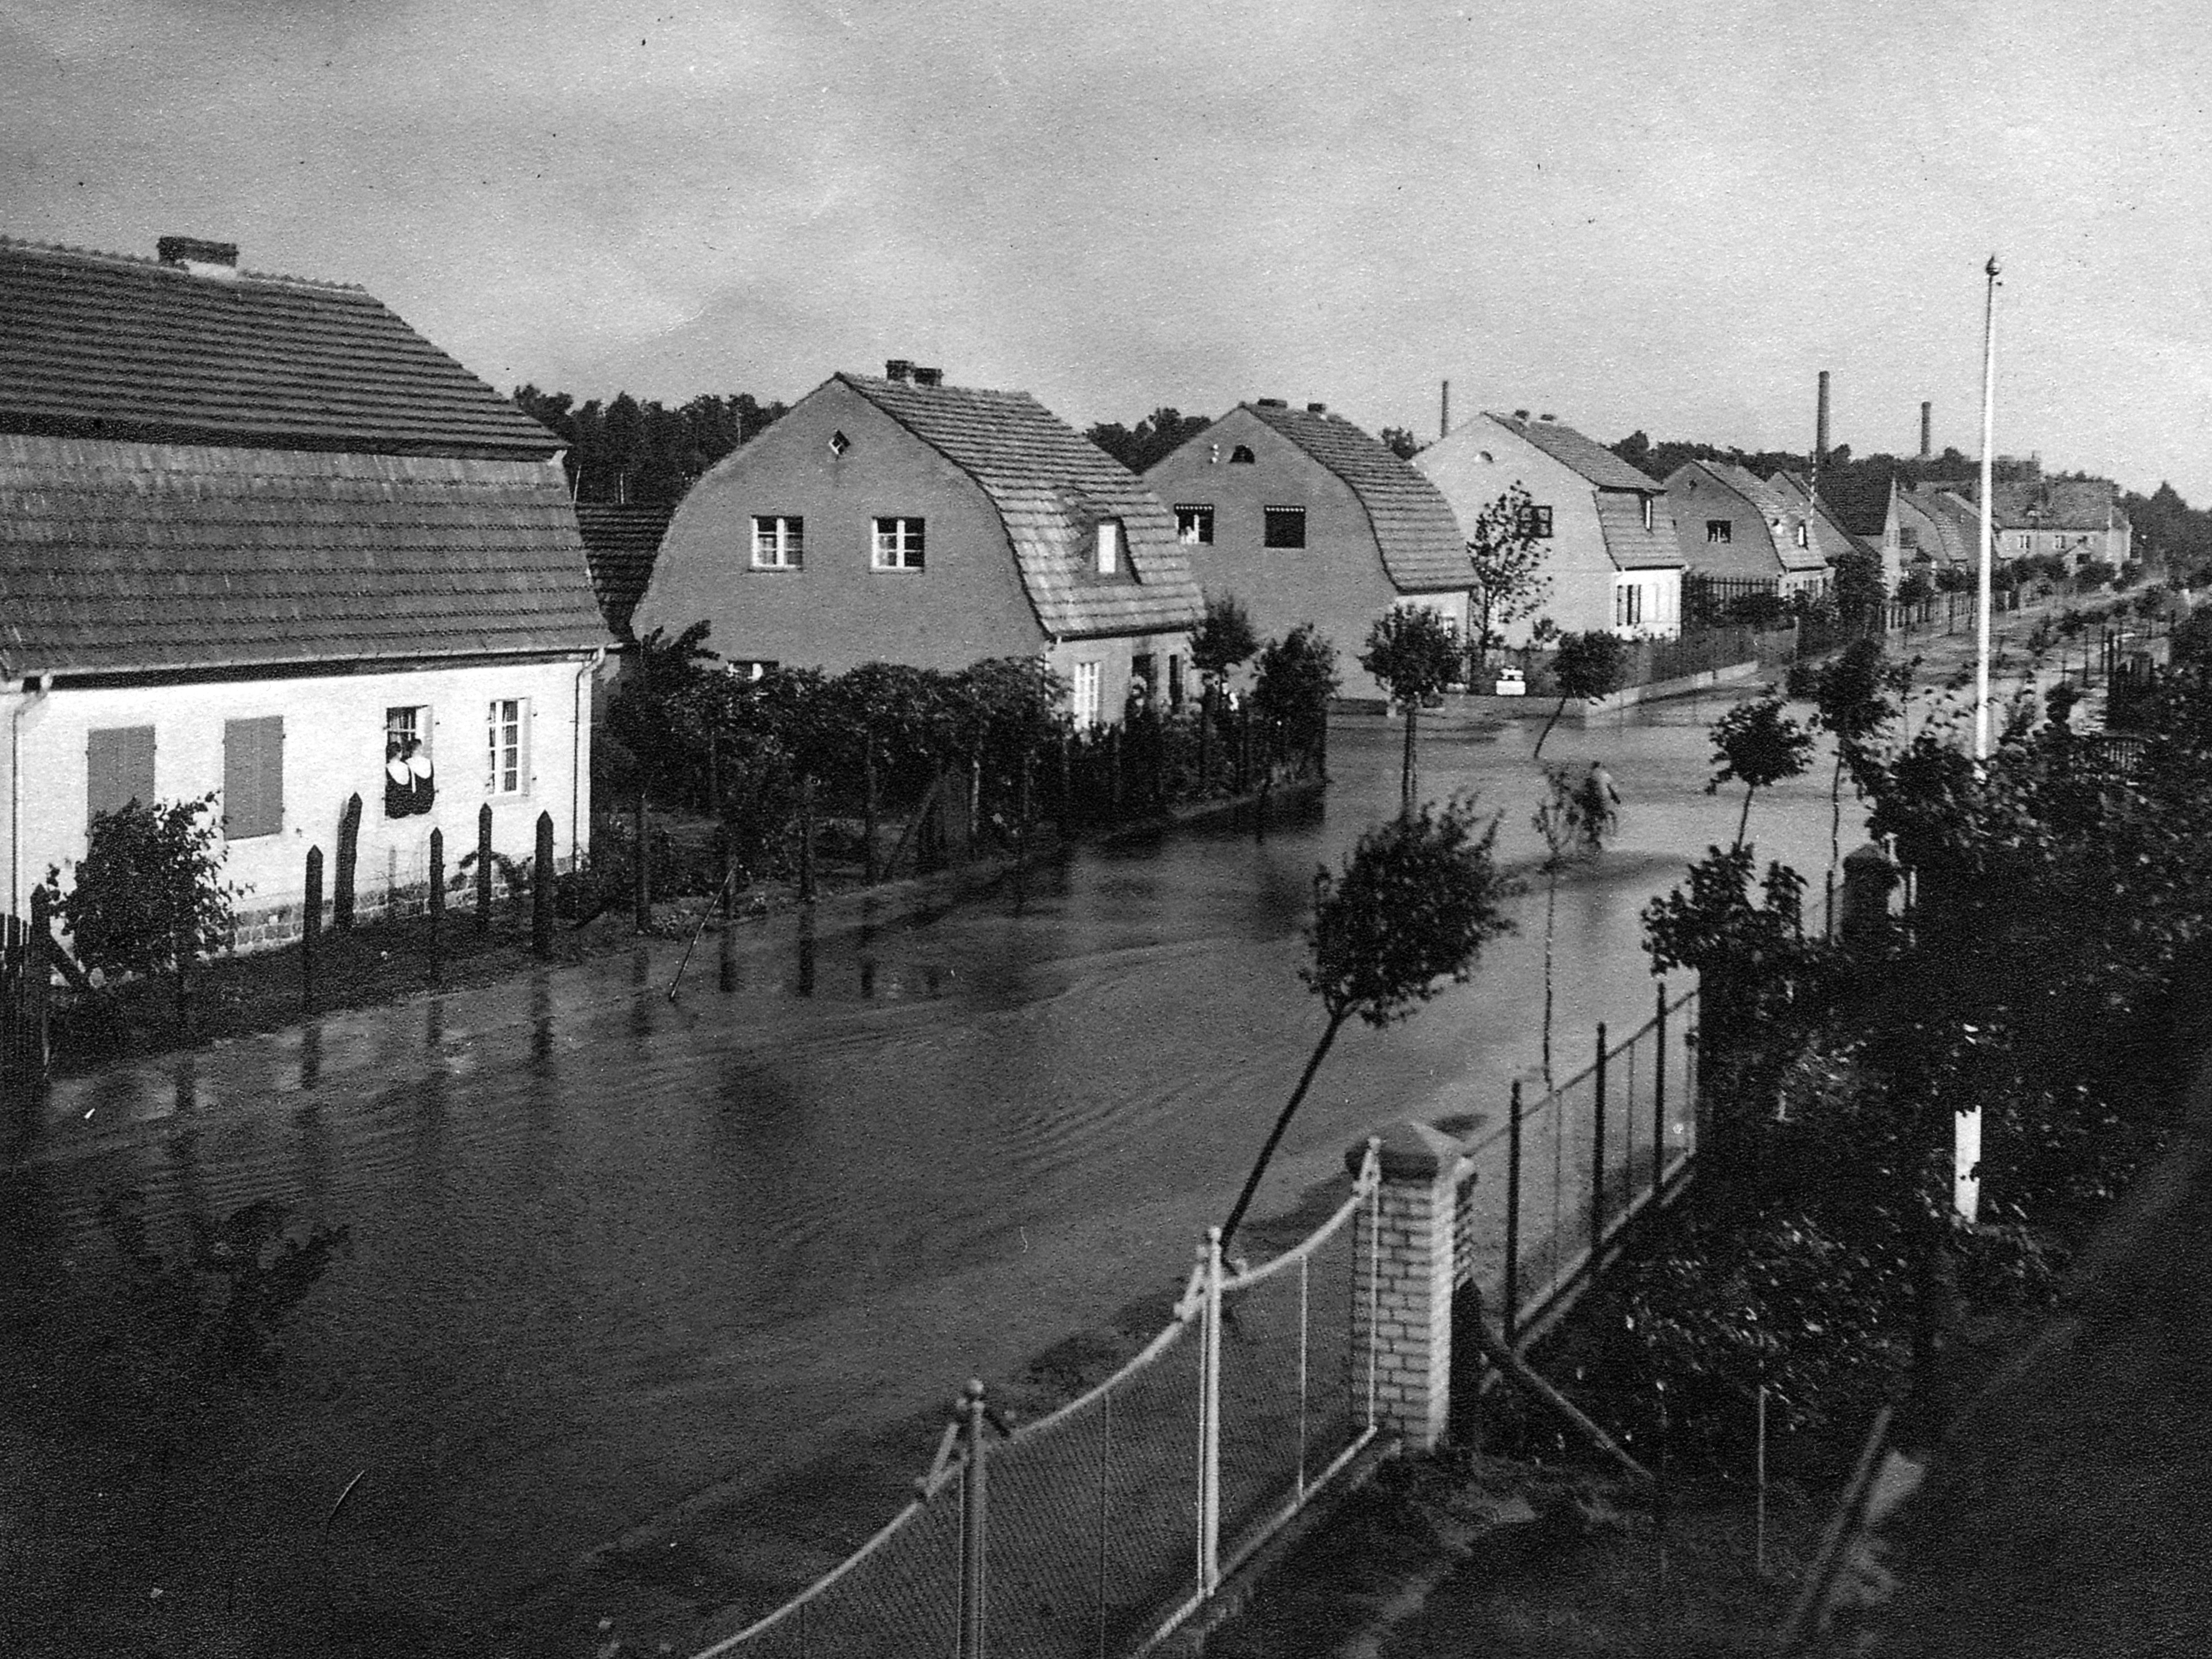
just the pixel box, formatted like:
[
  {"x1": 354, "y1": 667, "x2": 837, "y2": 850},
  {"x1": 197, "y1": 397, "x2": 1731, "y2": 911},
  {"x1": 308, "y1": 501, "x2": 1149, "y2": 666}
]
[{"x1": 699, "y1": 1150, "x2": 1382, "y2": 1659}]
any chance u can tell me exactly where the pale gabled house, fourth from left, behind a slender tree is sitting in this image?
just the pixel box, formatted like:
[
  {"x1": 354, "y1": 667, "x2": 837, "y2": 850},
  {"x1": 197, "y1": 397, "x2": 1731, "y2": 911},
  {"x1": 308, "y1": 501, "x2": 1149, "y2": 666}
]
[{"x1": 1414, "y1": 414, "x2": 1684, "y2": 646}]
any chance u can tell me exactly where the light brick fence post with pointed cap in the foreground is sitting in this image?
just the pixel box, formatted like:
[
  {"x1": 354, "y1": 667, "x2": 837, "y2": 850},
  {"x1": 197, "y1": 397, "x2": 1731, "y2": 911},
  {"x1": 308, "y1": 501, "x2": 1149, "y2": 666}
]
[{"x1": 1345, "y1": 1119, "x2": 1464, "y2": 1451}]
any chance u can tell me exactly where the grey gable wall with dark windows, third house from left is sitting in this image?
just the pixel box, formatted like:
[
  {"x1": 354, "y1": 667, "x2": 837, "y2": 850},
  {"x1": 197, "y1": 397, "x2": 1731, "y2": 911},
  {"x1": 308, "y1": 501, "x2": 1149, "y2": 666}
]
[{"x1": 1144, "y1": 409, "x2": 1467, "y2": 668}]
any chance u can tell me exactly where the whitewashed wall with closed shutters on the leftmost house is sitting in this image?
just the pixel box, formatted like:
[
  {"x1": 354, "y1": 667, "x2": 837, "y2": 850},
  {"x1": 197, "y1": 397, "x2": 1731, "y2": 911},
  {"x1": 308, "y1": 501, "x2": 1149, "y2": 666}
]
[{"x1": 0, "y1": 659, "x2": 591, "y2": 949}]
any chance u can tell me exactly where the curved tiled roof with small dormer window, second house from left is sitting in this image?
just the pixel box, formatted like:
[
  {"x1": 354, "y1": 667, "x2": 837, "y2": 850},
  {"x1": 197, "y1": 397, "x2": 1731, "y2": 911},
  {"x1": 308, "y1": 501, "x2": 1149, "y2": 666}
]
[{"x1": 836, "y1": 374, "x2": 1205, "y2": 639}]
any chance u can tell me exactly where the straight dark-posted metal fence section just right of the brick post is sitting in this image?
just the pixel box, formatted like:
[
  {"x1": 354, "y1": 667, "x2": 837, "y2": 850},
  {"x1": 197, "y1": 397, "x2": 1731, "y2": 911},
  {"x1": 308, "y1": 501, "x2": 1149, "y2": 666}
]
[{"x1": 1454, "y1": 986, "x2": 1697, "y2": 1340}]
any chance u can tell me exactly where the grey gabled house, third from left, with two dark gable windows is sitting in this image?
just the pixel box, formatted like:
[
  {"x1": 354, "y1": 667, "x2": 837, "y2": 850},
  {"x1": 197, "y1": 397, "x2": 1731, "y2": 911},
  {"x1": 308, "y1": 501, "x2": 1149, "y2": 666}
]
[{"x1": 1144, "y1": 398, "x2": 1473, "y2": 661}]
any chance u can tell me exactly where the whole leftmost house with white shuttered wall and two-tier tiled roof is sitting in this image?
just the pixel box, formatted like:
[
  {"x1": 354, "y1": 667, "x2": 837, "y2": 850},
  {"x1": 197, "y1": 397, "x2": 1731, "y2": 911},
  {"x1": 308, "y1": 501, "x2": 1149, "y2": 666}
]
[{"x1": 0, "y1": 237, "x2": 608, "y2": 947}]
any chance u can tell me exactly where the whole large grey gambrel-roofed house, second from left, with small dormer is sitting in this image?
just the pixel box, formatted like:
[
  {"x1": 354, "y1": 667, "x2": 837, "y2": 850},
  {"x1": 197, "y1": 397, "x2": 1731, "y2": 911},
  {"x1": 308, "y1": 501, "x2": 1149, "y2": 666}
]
[{"x1": 631, "y1": 358, "x2": 1203, "y2": 723}]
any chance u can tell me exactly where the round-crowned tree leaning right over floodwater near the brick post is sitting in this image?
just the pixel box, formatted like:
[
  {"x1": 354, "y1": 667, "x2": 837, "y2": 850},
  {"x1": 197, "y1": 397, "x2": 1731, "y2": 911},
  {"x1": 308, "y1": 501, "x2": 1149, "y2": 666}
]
[{"x1": 1221, "y1": 796, "x2": 1517, "y2": 1245}]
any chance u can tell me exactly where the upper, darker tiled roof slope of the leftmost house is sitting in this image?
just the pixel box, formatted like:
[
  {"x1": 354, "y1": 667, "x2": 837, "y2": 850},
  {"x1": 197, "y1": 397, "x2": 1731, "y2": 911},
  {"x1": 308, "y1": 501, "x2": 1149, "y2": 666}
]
[{"x1": 0, "y1": 241, "x2": 560, "y2": 460}]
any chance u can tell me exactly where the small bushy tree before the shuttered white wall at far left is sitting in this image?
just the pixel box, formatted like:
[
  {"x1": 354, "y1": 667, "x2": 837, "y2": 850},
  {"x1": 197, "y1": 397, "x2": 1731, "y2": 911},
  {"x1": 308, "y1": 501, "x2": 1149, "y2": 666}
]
[{"x1": 46, "y1": 794, "x2": 245, "y2": 973}]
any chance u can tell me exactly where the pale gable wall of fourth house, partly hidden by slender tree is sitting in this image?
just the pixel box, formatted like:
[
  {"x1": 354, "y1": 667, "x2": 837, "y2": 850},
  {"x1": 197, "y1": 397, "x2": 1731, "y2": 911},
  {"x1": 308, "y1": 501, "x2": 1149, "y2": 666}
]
[{"x1": 1414, "y1": 416, "x2": 1610, "y2": 646}]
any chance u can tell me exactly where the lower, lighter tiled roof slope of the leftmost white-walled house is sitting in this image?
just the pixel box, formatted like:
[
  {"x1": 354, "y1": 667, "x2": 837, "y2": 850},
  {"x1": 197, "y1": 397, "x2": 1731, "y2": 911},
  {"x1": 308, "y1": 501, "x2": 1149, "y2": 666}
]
[{"x1": 0, "y1": 433, "x2": 606, "y2": 679}]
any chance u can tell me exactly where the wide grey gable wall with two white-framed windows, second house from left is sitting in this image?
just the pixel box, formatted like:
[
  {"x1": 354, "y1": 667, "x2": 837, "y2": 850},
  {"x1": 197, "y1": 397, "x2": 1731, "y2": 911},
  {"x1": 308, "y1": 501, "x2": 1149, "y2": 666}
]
[{"x1": 631, "y1": 380, "x2": 1046, "y2": 673}]
